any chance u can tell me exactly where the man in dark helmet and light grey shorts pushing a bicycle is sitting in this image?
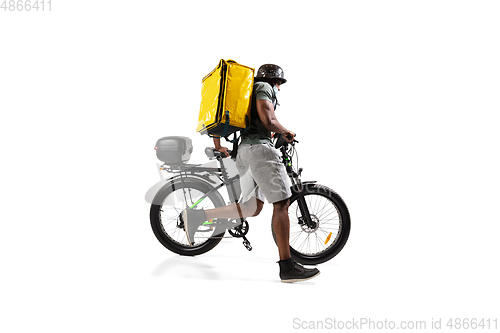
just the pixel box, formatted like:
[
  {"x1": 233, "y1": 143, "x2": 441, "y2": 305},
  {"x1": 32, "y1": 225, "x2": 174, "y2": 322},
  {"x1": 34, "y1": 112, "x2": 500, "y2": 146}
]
[{"x1": 181, "y1": 64, "x2": 319, "y2": 282}]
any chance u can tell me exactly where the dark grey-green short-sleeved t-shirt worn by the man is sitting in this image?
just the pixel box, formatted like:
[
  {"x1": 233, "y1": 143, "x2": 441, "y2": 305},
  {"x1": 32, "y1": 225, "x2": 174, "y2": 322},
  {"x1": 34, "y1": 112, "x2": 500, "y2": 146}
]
[{"x1": 241, "y1": 82, "x2": 274, "y2": 144}]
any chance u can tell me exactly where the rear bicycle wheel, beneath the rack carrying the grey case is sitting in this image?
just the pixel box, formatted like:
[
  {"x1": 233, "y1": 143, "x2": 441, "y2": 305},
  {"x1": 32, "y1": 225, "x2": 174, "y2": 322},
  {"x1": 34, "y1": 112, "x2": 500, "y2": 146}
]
[{"x1": 150, "y1": 179, "x2": 225, "y2": 256}]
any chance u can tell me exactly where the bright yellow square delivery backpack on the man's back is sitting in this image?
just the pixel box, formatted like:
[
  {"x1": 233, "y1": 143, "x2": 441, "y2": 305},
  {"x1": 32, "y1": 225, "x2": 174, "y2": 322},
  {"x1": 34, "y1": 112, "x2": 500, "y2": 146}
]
[{"x1": 196, "y1": 59, "x2": 254, "y2": 137}]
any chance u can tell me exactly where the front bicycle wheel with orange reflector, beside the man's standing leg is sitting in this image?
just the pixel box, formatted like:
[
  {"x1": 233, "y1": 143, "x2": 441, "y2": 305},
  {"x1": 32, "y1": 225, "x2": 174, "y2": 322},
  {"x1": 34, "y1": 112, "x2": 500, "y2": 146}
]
[{"x1": 271, "y1": 184, "x2": 351, "y2": 265}]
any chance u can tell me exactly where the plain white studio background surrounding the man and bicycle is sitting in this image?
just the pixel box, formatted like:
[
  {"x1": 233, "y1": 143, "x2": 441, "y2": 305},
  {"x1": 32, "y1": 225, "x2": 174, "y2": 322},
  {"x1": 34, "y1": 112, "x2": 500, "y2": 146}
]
[{"x1": 0, "y1": 0, "x2": 500, "y2": 332}]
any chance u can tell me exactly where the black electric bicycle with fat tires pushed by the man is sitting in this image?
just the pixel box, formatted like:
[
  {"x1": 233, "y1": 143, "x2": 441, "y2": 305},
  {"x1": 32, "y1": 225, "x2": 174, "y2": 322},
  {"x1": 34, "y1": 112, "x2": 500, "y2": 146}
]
[{"x1": 150, "y1": 135, "x2": 351, "y2": 265}]
